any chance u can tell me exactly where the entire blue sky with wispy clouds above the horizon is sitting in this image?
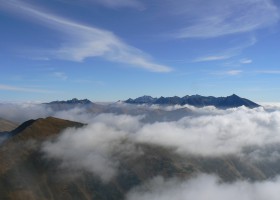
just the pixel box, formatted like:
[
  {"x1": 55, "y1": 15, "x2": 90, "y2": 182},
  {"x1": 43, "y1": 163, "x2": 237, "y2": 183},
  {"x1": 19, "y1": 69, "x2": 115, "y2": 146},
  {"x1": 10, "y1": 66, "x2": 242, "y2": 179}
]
[{"x1": 0, "y1": 0, "x2": 280, "y2": 102}]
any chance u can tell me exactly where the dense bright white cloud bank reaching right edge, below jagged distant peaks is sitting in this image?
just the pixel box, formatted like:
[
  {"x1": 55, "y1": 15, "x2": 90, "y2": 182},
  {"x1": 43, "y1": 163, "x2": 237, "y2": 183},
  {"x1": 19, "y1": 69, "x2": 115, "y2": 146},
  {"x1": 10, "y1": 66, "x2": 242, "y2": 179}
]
[{"x1": 135, "y1": 107, "x2": 280, "y2": 156}]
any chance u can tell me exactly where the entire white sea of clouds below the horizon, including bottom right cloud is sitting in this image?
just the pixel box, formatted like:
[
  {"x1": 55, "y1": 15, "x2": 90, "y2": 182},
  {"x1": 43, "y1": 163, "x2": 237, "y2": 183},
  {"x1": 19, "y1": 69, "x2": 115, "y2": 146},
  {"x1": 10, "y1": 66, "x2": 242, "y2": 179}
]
[{"x1": 0, "y1": 104, "x2": 280, "y2": 200}]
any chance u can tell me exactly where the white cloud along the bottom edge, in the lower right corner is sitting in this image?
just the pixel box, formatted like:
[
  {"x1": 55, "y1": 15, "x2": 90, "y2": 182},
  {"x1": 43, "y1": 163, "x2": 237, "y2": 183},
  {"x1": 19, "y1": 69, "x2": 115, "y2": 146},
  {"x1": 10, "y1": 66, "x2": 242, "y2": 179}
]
[{"x1": 126, "y1": 174, "x2": 280, "y2": 200}]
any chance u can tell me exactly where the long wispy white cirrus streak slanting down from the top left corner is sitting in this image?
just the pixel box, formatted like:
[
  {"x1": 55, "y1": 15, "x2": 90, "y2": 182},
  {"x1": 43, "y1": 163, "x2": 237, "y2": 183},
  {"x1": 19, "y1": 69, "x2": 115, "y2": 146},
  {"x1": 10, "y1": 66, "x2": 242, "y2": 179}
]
[{"x1": 2, "y1": 0, "x2": 172, "y2": 72}]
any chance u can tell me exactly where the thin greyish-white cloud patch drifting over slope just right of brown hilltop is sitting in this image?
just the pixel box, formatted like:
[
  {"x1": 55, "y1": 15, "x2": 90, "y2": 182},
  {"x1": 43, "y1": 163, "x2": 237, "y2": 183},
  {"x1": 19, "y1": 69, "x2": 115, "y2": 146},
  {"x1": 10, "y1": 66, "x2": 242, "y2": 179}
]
[{"x1": 42, "y1": 114, "x2": 141, "y2": 182}]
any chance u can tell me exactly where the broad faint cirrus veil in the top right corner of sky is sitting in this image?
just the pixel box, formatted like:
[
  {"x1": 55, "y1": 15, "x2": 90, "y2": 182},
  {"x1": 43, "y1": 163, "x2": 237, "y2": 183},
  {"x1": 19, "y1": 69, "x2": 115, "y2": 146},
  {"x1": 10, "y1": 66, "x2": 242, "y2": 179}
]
[{"x1": 173, "y1": 0, "x2": 279, "y2": 38}]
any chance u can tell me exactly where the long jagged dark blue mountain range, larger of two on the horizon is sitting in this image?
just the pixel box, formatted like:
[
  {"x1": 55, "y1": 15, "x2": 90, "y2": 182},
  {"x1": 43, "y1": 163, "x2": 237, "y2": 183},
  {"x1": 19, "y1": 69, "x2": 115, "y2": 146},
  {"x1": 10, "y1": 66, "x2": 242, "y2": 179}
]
[{"x1": 124, "y1": 94, "x2": 260, "y2": 108}]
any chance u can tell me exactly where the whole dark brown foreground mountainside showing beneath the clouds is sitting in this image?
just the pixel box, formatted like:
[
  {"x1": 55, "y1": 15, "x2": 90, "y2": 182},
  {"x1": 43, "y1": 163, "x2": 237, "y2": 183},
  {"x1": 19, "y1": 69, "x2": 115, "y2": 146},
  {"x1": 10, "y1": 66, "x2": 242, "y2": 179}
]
[{"x1": 0, "y1": 117, "x2": 280, "y2": 200}]
